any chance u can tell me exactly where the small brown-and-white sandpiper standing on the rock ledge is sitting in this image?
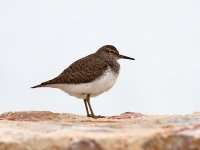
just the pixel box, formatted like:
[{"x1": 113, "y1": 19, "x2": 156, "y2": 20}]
[{"x1": 31, "y1": 45, "x2": 135, "y2": 119}]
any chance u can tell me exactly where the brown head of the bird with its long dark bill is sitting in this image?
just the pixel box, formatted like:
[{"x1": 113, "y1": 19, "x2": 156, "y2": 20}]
[{"x1": 96, "y1": 45, "x2": 135, "y2": 60}]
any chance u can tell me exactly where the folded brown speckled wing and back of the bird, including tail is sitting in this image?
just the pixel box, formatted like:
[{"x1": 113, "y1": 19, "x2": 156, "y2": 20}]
[{"x1": 33, "y1": 54, "x2": 108, "y2": 88}]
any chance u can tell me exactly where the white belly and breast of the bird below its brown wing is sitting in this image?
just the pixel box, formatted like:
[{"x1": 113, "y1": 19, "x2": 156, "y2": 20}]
[{"x1": 48, "y1": 68, "x2": 118, "y2": 98}]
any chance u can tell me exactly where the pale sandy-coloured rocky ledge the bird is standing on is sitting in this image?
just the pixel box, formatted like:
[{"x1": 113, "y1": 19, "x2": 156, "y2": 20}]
[{"x1": 0, "y1": 111, "x2": 200, "y2": 150}]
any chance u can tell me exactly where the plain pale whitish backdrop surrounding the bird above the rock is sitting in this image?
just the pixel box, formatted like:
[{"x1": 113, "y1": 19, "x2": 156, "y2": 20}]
[{"x1": 0, "y1": 0, "x2": 200, "y2": 115}]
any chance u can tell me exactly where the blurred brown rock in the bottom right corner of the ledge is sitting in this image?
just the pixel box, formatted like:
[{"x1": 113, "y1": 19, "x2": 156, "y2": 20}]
[{"x1": 143, "y1": 125, "x2": 200, "y2": 150}]
